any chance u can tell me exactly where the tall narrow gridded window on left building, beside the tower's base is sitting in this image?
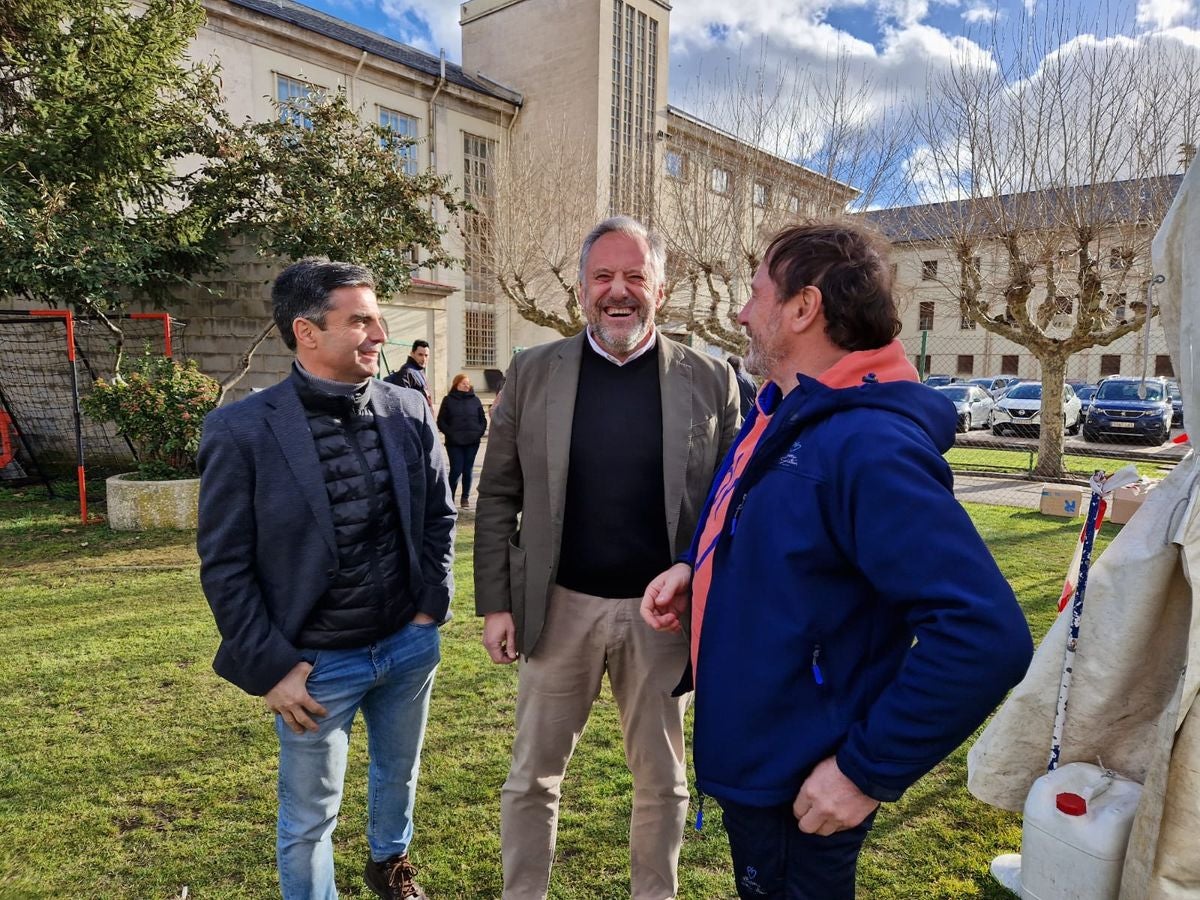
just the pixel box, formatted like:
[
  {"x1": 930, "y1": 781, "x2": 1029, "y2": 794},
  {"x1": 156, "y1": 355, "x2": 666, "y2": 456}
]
[{"x1": 463, "y1": 132, "x2": 497, "y2": 366}]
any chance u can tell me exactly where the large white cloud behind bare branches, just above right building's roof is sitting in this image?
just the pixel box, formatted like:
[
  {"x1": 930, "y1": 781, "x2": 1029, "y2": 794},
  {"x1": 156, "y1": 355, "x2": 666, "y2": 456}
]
[{"x1": 906, "y1": 28, "x2": 1200, "y2": 202}]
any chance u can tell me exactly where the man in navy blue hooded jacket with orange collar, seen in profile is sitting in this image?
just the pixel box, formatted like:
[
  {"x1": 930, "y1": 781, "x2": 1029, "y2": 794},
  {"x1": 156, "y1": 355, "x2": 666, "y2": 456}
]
[{"x1": 642, "y1": 223, "x2": 1032, "y2": 900}]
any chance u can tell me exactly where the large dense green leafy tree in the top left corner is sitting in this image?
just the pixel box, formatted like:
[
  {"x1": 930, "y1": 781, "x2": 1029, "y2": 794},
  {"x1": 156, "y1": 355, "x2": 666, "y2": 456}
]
[{"x1": 0, "y1": 0, "x2": 228, "y2": 345}]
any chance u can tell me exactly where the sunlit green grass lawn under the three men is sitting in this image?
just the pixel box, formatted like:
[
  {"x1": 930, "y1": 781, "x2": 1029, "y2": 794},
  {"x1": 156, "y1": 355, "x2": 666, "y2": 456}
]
[{"x1": 0, "y1": 490, "x2": 1115, "y2": 900}]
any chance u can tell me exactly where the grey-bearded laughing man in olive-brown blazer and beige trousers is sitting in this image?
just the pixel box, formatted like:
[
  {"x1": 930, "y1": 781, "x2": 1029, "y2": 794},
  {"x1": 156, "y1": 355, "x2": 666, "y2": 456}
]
[{"x1": 475, "y1": 216, "x2": 739, "y2": 900}]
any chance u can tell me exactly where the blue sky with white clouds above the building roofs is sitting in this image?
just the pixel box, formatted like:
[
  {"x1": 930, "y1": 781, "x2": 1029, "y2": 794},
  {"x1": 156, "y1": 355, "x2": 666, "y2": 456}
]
[{"x1": 292, "y1": 0, "x2": 1200, "y2": 202}]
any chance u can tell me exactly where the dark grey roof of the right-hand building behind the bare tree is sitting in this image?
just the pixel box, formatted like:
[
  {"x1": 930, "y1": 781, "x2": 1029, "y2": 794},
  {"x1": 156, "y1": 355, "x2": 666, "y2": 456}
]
[{"x1": 863, "y1": 175, "x2": 1183, "y2": 242}]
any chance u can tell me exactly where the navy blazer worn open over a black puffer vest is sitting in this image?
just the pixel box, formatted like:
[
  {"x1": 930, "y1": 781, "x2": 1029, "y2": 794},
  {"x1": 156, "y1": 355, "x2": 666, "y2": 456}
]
[{"x1": 196, "y1": 379, "x2": 457, "y2": 695}]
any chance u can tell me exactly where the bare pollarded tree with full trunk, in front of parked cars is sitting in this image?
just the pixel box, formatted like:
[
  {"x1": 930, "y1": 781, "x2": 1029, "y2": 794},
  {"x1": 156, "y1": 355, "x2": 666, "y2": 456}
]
[{"x1": 892, "y1": 6, "x2": 1200, "y2": 478}]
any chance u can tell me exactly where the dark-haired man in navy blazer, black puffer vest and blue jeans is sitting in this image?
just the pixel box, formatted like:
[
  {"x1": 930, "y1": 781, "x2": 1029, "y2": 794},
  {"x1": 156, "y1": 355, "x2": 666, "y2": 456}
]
[{"x1": 197, "y1": 258, "x2": 456, "y2": 898}]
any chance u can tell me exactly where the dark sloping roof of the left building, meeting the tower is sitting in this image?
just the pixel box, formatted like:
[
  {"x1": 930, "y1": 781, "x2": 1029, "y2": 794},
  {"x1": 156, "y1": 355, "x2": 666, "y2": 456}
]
[{"x1": 226, "y1": 0, "x2": 523, "y2": 106}]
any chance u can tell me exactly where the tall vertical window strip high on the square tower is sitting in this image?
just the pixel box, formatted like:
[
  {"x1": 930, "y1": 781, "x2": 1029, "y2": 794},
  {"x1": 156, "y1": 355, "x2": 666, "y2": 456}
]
[{"x1": 608, "y1": 0, "x2": 659, "y2": 216}]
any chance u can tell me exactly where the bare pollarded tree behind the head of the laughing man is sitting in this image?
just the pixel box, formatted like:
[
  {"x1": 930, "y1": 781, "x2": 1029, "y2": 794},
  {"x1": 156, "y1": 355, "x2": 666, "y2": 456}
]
[{"x1": 477, "y1": 55, "x2": 910, "y2": 352}]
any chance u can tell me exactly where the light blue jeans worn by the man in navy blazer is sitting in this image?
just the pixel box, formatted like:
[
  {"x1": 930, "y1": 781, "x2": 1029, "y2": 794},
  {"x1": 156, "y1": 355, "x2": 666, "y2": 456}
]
[{"x1": 275, "y1": 624, "x2": 442, "y2": 900}]
